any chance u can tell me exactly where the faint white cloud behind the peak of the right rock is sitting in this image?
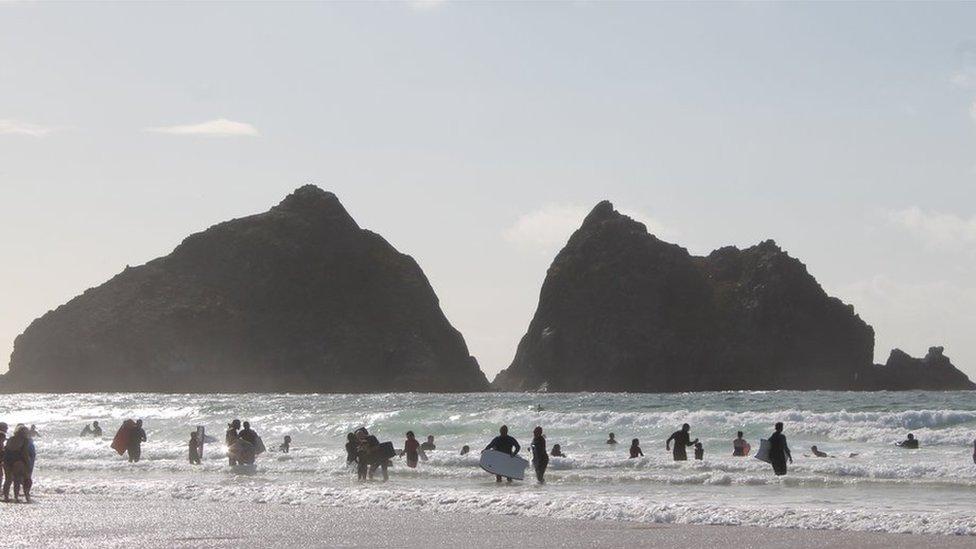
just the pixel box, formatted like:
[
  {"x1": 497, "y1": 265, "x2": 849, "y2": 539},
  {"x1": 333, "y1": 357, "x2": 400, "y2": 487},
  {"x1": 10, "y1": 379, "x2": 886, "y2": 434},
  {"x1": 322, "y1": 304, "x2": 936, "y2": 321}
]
[{"x1": 503, "y1": 204, "x2": 674, "y2": 253}]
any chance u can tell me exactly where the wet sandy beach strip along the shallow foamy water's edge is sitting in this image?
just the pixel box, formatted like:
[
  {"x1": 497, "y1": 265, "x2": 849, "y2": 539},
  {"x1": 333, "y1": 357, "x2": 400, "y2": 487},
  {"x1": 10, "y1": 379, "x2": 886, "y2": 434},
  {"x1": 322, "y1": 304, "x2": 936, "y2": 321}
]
[{"x1": 7, "y1": 492, "x2": 976, "y2": 548}]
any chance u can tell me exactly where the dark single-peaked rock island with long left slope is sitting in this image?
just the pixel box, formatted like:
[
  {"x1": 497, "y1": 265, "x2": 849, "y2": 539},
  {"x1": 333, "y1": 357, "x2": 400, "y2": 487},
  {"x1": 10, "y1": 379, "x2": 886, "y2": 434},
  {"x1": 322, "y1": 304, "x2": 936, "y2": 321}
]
[{"x1": 4, "y1": 185, "x2": 487, "y2": 392}]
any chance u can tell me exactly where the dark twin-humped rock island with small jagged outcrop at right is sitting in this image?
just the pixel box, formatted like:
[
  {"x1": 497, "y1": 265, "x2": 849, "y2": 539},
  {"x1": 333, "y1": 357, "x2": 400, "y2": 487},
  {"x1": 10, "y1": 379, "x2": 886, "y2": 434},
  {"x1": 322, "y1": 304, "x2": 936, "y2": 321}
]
[{"x1": 493, "y1": 202, "x2": 974, "y2": 392}]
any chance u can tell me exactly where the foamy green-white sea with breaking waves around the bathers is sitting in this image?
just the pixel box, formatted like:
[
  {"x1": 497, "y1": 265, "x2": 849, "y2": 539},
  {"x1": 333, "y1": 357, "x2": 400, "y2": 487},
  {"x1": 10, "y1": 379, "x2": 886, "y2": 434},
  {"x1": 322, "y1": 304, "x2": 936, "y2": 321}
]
[{"x1": 0, "y1": 391, "x2": 976, "y2": 535}]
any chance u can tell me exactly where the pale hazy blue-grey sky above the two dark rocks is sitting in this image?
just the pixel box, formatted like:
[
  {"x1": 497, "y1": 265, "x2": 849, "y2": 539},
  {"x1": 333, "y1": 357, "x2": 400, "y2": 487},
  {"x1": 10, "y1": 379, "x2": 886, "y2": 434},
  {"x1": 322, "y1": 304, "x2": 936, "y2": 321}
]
[{"x1": 0, "y1": 1, "x2": 976, "y2": 379}]
